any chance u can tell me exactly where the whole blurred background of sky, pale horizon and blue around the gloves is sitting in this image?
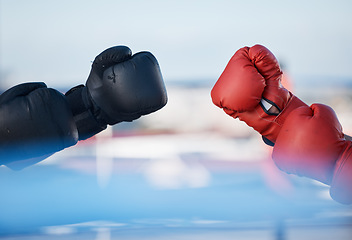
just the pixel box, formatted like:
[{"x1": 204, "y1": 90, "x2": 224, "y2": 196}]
[{"x1": 0, "y1": 0, "x2": 352, "y2": 240}]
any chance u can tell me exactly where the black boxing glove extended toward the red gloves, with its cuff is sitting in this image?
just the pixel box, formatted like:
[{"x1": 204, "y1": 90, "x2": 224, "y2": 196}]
[{"x1": 65, "y1": 46, "x2": 167, "y2": 140}]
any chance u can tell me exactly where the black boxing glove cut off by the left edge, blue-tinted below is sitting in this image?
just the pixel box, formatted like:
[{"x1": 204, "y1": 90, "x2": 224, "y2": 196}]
[{"x1": 0, "y1": 83, "x2": 78, "y2": 169}]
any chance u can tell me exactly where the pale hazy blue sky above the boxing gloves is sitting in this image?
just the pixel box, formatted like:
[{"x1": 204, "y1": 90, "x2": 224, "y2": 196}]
[{"x1": 0, "y1": 0, "x2": 352, "y2": 87}]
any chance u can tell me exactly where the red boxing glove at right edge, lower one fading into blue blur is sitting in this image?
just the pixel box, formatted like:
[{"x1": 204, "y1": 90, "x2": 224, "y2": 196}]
[{"x1": 272, "y1": 104, "x2": 352, "y2": 204}]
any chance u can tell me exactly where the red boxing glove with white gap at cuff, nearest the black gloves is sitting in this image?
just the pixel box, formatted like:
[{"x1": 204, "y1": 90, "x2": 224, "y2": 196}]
[{"x1": 211, "y1": 45, "x2": 306, "y2": 145}]
